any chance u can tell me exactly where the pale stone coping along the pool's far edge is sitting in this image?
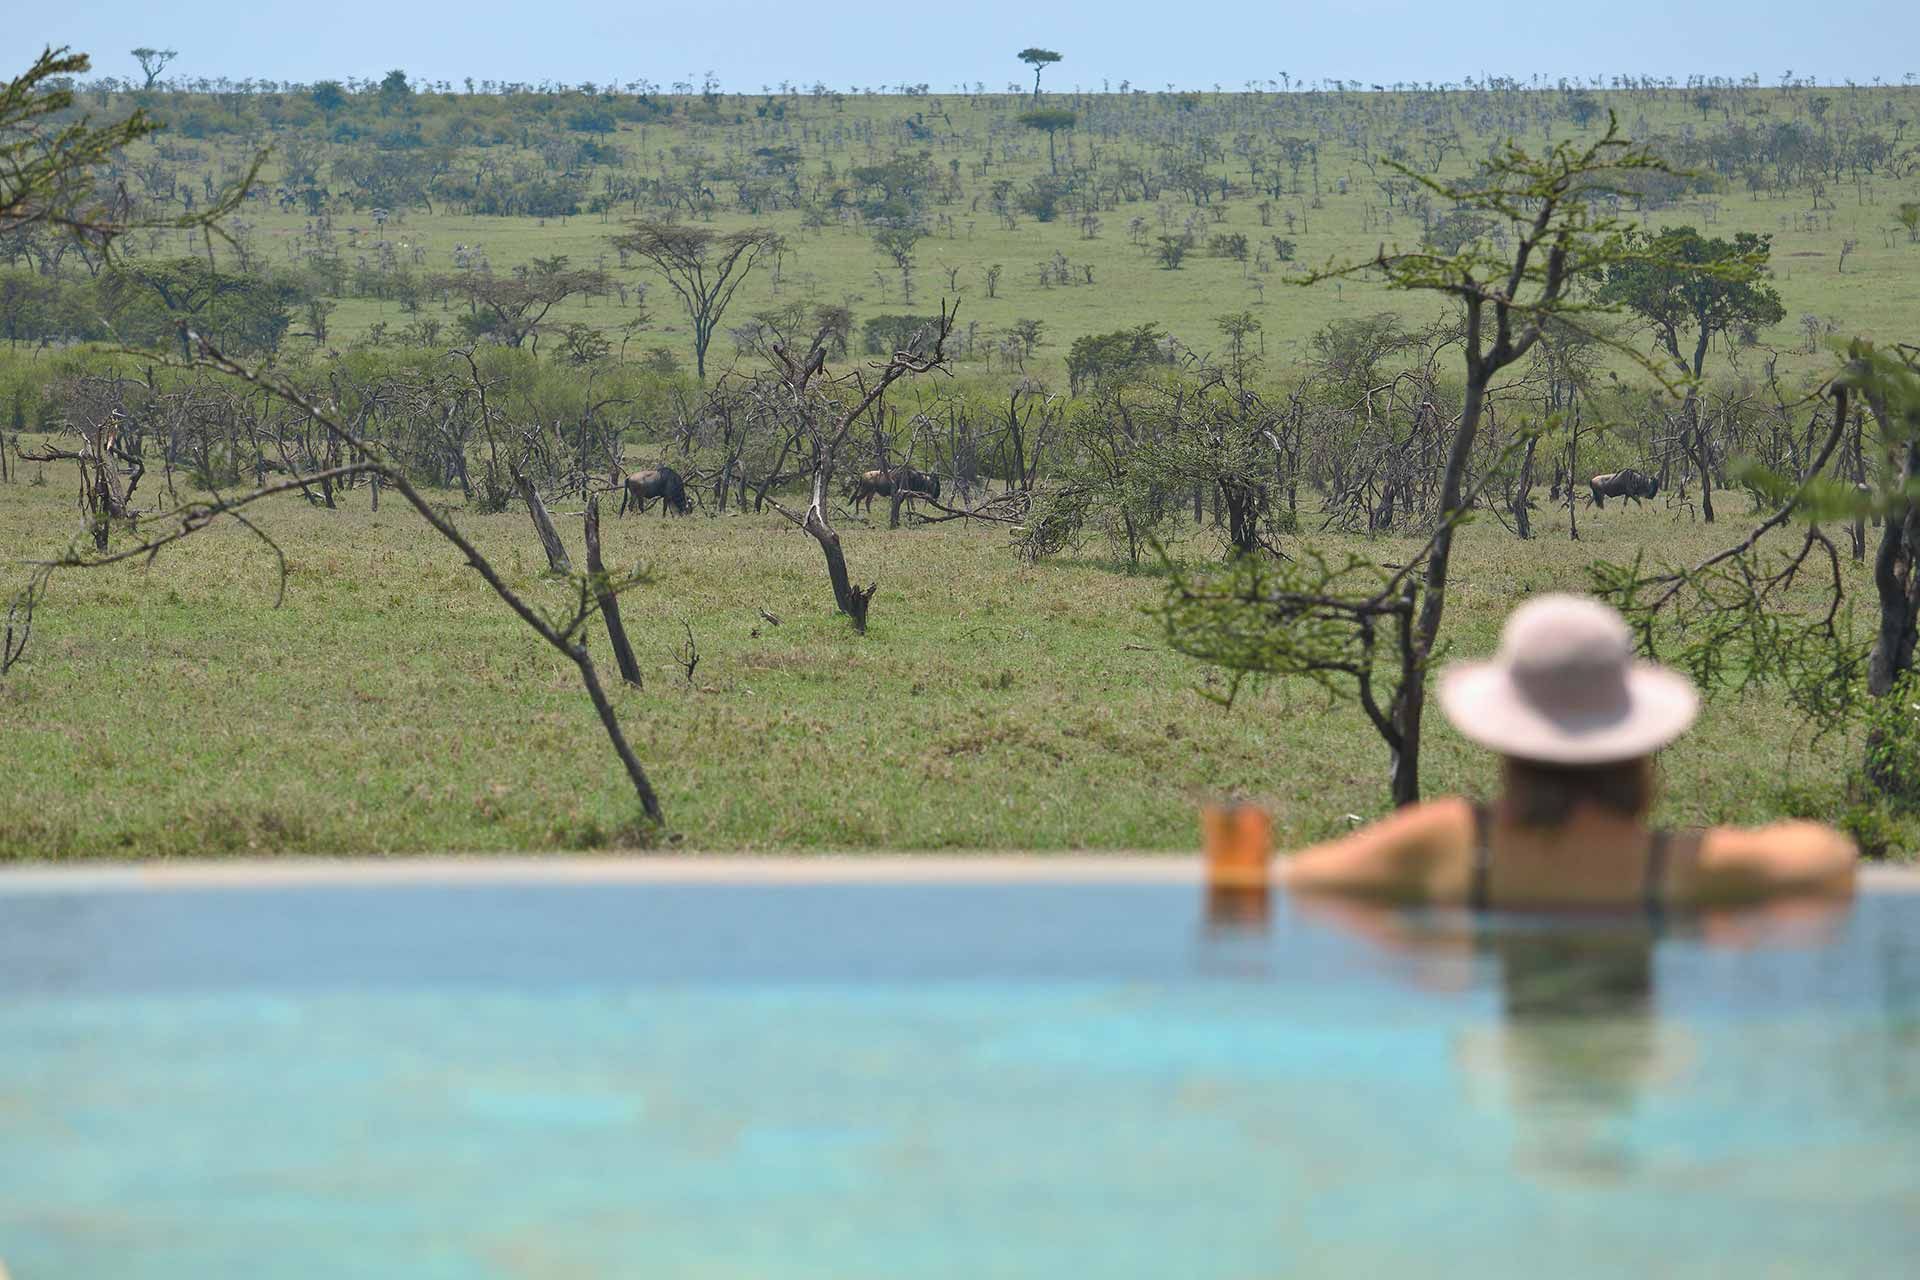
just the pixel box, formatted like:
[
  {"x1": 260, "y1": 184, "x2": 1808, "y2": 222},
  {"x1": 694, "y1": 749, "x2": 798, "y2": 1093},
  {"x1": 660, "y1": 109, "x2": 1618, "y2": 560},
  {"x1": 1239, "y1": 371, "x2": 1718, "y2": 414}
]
[{"x1": 0, "y1": 854, "x2": 1920, "y2": 894}]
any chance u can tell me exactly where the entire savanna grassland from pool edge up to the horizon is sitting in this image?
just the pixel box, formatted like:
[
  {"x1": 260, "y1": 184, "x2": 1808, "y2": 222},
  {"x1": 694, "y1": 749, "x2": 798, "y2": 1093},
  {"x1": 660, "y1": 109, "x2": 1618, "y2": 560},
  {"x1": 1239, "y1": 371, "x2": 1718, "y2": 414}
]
[{"x1": 0, "y1": 73, "x2": 1920, "y2": 858}]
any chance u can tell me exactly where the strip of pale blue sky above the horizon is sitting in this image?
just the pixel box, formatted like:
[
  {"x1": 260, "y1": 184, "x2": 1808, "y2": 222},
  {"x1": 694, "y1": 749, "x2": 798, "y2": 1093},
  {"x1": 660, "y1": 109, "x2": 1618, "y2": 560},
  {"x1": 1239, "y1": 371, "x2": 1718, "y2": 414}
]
[{"x1": 0, "y1": 0, "x2": 1920, "y2": 90}]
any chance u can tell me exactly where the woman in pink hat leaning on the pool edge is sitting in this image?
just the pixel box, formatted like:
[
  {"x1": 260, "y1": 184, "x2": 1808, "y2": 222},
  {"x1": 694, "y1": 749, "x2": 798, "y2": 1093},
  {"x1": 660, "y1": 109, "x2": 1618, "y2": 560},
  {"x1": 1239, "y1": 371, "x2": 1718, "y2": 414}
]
[{"x1": 1281, "y1": 595, "x2": 1857, "y2": 910}]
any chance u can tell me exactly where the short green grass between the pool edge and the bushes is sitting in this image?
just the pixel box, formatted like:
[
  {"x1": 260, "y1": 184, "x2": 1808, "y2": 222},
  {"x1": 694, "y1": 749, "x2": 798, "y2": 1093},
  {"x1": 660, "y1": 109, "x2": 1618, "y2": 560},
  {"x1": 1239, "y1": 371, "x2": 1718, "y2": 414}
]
[{"x1": 0, "y1": 468, "x2": 1910, "y2": 858}]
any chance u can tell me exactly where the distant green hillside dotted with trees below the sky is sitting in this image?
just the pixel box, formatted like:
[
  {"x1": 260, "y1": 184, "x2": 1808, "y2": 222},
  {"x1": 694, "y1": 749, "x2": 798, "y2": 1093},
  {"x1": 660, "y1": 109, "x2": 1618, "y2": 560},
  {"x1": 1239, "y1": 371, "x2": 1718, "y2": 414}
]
[{"x1": 3, "y1": 77, "x2": 1920, "y2": 380}]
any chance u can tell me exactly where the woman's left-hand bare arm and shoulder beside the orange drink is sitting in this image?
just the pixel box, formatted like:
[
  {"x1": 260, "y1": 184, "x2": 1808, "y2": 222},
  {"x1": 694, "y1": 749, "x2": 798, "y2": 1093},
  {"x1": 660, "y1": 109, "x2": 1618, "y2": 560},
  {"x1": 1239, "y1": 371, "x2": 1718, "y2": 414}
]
[{"x1": 1281, "y1": 796, "x2": 1473, "y2": 900}]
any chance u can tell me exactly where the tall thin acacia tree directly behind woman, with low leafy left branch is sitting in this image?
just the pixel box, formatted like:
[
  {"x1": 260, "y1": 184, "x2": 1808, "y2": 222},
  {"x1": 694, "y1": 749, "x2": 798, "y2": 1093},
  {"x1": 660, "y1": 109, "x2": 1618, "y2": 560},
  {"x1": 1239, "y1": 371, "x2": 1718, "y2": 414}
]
[{"x1": 1162, "y1": 119, "x2": 1689, "y2": 804}]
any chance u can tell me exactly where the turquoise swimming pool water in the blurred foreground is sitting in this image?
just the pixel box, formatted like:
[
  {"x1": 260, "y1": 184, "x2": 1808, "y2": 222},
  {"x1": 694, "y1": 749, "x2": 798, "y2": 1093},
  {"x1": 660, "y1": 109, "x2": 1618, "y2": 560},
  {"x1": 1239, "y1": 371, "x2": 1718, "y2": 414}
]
[{"x1": 0, "y1": 883, "x2": 1920, "y2": 1280}]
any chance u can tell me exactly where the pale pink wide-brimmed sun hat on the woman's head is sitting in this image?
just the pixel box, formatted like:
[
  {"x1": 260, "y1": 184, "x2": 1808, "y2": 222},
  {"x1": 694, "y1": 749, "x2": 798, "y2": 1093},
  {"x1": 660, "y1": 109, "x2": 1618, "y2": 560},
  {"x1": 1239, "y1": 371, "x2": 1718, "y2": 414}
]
[{"x1": 1440, "y1": 595, "x2": 1699, "y2": 764}]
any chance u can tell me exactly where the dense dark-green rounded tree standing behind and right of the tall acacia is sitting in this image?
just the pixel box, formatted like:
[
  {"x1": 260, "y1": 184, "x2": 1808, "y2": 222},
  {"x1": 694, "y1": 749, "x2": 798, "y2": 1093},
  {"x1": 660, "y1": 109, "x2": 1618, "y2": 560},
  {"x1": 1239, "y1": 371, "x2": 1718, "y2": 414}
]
[{"x1": 1599, "y1": 226, "x2": 1786, "y2": 524}]
